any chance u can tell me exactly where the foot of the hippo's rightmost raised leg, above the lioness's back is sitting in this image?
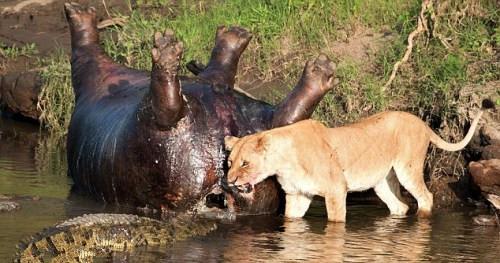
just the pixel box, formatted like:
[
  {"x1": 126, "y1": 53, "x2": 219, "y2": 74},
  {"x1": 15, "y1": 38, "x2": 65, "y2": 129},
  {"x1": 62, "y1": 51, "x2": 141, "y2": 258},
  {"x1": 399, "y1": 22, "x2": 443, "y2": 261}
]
[{"x1": 302, "y1": 54, "x2": 338, "y2": 93}]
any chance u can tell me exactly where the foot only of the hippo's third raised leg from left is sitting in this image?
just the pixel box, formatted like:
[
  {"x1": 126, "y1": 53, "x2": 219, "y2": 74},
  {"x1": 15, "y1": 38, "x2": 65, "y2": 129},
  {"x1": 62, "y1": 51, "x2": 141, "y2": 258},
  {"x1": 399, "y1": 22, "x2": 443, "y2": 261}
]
[{"x1": 215, "y1": 26, "x2": 252, "y2": 56}]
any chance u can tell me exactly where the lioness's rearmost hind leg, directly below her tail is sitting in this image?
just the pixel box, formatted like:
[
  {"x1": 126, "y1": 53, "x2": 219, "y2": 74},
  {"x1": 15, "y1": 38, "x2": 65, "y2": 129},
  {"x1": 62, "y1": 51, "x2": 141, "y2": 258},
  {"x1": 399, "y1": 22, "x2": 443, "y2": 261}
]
[{"x1": 394, "y1": 163, "x2": 433, "y2": 217}]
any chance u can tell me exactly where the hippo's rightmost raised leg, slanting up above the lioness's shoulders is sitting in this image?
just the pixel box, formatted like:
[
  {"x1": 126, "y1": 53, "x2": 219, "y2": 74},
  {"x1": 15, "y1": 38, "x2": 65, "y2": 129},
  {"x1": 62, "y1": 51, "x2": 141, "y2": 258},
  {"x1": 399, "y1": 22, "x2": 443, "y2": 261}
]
[{"x1": 272, "y1": 54, "x2": 336, "y2": 128}]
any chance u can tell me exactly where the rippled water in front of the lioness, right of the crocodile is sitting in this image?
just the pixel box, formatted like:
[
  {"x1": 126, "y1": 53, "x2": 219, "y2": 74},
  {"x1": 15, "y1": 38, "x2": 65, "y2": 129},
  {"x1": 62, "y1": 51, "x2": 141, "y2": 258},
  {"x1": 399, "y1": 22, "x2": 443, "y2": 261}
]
[{"x1": 150, "y1": 203, "x2": 500, "y2": 262}]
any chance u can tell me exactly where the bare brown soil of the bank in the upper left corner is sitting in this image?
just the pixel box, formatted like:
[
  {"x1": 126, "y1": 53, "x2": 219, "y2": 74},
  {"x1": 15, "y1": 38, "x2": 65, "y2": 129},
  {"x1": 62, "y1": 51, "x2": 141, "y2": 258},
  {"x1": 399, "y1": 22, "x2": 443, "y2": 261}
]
[{"x1": 0, "y1": 0, "x2": 128, "y2": 74}]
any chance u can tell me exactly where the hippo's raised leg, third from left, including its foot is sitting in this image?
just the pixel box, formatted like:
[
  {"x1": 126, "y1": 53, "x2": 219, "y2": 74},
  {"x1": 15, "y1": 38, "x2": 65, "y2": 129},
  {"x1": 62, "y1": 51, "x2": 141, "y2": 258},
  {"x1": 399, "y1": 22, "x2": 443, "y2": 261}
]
[{"x1": 192, "y1": 26, "x2": 252, "y2": 86}]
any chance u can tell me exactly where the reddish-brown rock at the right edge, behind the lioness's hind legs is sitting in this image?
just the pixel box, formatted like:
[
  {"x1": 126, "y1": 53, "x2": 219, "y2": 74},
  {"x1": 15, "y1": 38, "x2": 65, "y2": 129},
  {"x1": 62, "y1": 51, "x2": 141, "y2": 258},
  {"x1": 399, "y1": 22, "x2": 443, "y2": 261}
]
[{"x1": 469, "y1": 159, "x2": 500, "y2": 209}]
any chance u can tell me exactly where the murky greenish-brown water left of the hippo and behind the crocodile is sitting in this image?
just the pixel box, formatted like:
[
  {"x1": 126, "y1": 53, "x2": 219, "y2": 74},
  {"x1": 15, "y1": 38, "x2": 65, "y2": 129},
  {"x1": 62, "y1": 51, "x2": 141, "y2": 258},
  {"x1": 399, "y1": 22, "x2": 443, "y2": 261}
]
[{"x1": 0, "y1": 118, "x2": 102, "y2": 262}]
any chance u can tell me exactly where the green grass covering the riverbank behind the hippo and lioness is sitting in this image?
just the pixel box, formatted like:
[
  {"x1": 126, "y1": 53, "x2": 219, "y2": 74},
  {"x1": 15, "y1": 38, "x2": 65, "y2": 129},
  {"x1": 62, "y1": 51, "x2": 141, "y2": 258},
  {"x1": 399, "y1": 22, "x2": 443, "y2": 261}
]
[{"x1": 34, "y1": 0, "x2": 500, "y2": 142}]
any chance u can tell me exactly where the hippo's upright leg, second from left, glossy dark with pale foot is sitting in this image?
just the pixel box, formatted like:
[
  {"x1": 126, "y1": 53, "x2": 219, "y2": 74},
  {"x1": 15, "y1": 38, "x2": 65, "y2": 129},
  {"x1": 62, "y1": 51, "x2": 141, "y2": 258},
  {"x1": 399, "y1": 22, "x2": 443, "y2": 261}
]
[{"x1": 150, "y1": 30, "x2": 185, "y2": 129}]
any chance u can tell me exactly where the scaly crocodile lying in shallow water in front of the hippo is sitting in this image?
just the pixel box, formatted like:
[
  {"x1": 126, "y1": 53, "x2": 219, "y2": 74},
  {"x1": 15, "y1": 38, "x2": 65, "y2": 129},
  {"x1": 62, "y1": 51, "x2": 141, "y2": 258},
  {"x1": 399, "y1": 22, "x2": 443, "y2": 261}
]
[{"x1": 14, "y1": 213, "x2": 217, "y2": 262}]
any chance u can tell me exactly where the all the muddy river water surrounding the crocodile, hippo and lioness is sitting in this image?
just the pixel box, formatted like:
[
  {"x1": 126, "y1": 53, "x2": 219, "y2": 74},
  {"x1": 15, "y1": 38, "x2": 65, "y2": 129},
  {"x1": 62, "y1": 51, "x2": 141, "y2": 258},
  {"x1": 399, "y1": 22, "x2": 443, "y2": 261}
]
[{"x1": 0, "y1": 120, "x2": 500, "y2": 262}]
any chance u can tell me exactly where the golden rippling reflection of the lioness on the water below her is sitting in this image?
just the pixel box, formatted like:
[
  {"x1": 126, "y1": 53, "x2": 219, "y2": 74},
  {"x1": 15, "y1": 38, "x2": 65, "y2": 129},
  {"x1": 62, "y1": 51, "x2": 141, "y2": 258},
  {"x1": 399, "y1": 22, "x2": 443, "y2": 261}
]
[{"x1": 220, "y1": 207, "x2": 431, "y2": 262}]
